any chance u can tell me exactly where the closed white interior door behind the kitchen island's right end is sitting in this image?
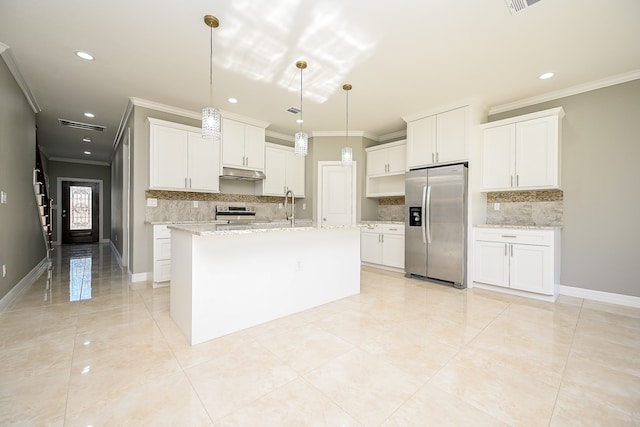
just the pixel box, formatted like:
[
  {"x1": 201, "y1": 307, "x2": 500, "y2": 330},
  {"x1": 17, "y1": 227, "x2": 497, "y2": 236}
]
[{"x1": 318, "y1": 162, "x2": 357, "y2": 227}]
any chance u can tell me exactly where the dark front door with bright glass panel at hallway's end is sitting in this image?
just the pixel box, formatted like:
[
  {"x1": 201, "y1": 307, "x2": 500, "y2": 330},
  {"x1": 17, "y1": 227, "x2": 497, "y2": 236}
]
[{"x1": 61, "y1": 181, "x2": 100, "y2": 245}]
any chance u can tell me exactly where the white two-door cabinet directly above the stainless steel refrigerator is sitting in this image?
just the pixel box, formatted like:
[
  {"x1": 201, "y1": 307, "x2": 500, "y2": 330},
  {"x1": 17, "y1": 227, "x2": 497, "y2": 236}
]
[{"x1": 407, "y1": 107, "x2": 469, "y2": 169}]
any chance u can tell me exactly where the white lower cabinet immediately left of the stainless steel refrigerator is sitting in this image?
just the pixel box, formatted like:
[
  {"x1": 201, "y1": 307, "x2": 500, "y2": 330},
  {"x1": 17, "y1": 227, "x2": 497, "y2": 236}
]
[{"x1": 360, "y1": 223, "x2": 404, "y2": 269}]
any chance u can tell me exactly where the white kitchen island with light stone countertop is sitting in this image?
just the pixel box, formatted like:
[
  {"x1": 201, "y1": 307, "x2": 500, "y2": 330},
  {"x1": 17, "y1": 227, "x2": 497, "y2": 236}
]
[{"x1": 169, "y1": 223, "x2": 360, "y2": 345}]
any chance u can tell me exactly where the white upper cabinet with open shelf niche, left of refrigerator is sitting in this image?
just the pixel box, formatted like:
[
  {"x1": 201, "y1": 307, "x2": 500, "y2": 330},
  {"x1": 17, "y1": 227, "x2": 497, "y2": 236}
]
[{"x1": 365, "y1": 140, "x2": 407, "y2": 197}]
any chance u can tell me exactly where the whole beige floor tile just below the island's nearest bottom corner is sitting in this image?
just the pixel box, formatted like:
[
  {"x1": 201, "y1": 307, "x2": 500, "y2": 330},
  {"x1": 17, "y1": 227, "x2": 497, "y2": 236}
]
[{"x1": 185, "y1": 342, "x2": 298, "y2": 420}]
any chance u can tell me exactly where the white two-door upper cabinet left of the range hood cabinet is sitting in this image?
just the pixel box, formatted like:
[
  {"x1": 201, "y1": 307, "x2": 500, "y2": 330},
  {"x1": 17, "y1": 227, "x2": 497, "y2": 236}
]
[{"x1": 148, "y1": 118, "x2": 220, "y2": 193}]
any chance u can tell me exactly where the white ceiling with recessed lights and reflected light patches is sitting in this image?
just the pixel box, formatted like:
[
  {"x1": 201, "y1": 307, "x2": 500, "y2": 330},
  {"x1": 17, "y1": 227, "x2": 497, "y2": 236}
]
[{"x1": 0, "y1": 0, "x2": 640, "y2": 162}]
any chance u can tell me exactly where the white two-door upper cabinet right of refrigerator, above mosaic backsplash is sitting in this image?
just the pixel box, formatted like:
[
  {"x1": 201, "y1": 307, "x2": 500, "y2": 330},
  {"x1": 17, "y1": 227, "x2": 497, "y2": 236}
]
[{"x1": 481, "y1": 108, "x2": 564, "y2": 191}]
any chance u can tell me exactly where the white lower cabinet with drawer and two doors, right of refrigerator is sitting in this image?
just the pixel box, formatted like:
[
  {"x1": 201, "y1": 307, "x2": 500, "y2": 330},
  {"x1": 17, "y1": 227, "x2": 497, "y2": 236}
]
[{"x1": 473, "y1": 227, "x2": 560, "y2": 295}]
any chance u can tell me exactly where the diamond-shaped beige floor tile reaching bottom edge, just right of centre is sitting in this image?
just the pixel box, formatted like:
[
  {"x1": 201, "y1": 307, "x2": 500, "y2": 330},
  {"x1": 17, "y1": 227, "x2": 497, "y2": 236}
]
[{"x1": 305, "y1": 349, "x2": 423, "y2": 426}]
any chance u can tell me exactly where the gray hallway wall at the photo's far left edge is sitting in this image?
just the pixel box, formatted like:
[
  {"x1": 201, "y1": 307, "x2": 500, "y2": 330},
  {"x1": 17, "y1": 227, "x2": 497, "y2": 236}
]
[{"x1": 0, "y1": 60, "x2": 46, "y2": 298}]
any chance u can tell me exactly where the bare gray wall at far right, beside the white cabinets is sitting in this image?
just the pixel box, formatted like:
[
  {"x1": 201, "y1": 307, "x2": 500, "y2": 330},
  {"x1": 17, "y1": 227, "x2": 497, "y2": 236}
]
[{"x1": 490, "y1": 80, "x2": 640, "y2": 297}]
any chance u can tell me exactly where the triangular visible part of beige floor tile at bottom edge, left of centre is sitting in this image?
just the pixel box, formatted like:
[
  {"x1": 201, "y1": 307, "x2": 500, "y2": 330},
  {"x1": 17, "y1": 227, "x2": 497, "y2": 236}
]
[{"x1": 216, "y1": 378, "x2": 361, "y2": 427}]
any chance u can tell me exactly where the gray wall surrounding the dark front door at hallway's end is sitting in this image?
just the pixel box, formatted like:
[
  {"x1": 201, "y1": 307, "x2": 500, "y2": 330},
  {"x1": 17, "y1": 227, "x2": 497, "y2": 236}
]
[{"x1": 47, "y1": 160, "x2": 111, "y2": 241}]
